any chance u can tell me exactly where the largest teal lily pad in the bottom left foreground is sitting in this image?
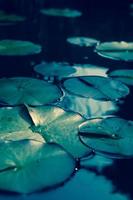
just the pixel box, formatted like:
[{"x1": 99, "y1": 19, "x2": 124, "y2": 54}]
[{"x1": 0, "y1": 140, "x2": 75, "y2": 193}]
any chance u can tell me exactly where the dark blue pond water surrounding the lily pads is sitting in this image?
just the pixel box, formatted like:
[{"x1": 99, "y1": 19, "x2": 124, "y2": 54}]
[{"x1": 0, "y1": 0, "x2": 133, "y2": 200}]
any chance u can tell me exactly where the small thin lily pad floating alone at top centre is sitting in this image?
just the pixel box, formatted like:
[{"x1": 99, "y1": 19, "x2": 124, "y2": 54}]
[{"x1": 40, "y1": 8, "x2": 82, "y2": 18}]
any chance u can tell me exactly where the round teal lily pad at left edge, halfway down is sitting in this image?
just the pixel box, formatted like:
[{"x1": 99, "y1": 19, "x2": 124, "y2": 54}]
[{"x1": 0, "y1": 77, "x2": 62, "y2": 106}]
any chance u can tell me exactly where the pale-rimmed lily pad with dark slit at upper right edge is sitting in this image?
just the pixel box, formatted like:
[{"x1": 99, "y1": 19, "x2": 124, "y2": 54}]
[{"x1": 96, "y1": 41, "x2": 133, "y2": 61}]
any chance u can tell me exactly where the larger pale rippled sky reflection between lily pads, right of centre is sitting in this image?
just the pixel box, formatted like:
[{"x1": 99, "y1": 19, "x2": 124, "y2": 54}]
[{"x1": 56, "y1": 92, "x2": 118, "y2": 119}]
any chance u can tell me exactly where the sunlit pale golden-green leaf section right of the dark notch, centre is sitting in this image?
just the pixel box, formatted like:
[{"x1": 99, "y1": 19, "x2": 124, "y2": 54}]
[{"x1": 28, "y1": 106, "x2": 90, "y2": 158}]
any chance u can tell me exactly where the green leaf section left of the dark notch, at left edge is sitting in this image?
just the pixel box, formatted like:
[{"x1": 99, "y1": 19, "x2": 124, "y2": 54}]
[{"x1": 0, "y1": 107, "x2": 32, "y2": 135}]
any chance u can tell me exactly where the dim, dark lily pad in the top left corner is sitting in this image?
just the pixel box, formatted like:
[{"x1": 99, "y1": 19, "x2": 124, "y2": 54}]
[{"x1": 0, "y1": 10, "x2": 26, "y2": 25}]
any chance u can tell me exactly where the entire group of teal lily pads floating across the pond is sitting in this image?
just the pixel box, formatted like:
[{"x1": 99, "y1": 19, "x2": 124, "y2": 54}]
[{"x1": 0, "y1": 3, "x2": 133, "y2": 196}]
